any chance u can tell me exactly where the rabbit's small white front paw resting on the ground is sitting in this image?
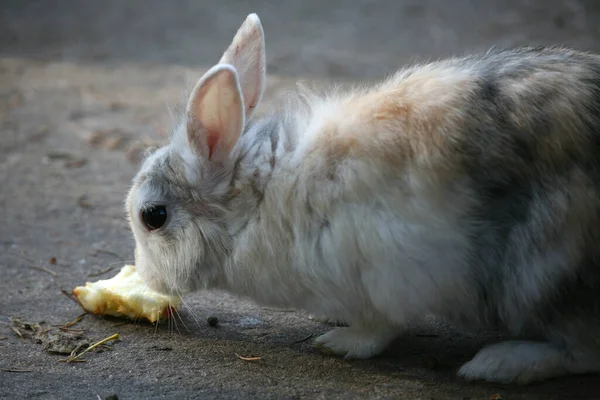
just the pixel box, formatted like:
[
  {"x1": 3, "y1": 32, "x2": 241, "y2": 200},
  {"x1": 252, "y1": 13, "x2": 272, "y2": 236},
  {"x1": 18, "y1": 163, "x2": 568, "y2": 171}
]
[{"x1": 314, "y1": 327, "x2": 397, "y2": 359}]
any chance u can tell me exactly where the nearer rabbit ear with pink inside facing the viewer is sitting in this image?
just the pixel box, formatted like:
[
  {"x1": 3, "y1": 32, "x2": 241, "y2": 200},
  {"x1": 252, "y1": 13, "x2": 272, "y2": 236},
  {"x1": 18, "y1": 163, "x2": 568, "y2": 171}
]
[{"x1": 186, "y1": 64, "x2": 245, "y2": 160}]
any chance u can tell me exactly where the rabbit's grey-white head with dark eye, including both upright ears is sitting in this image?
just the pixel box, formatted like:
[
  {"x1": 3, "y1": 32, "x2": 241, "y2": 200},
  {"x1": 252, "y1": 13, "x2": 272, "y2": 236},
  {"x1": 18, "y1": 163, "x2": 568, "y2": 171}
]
[{"x1": 126, "y1": 14, "x2": 265, "y2": 294}]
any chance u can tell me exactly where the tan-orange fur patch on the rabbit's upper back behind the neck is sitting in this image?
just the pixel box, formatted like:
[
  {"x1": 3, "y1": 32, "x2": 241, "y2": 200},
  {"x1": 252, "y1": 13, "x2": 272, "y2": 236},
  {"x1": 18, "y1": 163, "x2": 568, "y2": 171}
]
[{"x1": 314, "y1": 65, "x2": 472, "y2": 180}]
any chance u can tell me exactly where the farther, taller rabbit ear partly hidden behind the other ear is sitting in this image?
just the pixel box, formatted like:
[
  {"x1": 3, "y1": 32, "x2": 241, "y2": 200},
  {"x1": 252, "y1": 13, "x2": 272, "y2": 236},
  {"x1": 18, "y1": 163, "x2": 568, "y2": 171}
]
[{"x1": 219, "y1": 14, "x2": 266, "y2": 117}]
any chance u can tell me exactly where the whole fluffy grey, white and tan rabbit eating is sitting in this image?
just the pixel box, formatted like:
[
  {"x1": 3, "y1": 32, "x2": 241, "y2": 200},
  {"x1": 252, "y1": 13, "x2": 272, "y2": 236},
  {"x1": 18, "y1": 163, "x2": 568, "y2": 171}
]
[{"x1": 126, "y1": 14, "x2": 600, "y2": 384}]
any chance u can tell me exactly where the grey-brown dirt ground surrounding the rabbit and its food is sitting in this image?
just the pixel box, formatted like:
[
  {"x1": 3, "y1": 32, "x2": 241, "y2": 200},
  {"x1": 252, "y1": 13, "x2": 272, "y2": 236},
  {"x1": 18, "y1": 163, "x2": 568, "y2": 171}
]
[{"x1": 0, "y1": 0, "x2": 600, "y2": 399}]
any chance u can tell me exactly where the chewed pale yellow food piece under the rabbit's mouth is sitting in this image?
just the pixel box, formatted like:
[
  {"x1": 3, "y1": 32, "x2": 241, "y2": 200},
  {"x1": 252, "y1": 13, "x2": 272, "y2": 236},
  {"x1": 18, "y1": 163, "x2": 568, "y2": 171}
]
[{"x1": 73, "y1": 265, "x2": 181, "y2": 322}]
